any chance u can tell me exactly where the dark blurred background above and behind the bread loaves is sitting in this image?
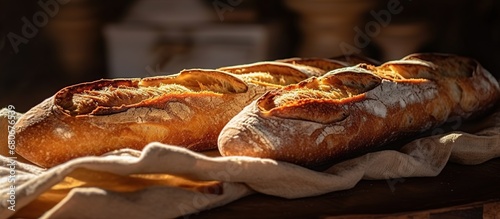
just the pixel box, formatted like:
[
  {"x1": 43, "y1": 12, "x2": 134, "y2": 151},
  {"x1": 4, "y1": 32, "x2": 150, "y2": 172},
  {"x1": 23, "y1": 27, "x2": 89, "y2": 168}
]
[{"x1": 0, "y1": 0, "x2": 500, "y2": 112}]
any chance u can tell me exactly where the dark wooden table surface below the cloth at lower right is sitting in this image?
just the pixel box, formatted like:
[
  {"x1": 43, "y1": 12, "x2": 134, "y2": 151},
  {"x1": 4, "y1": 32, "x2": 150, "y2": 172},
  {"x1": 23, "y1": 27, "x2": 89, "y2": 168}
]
[{"x1": 185, "y1": 158, "x2": 500, "y2": 218}]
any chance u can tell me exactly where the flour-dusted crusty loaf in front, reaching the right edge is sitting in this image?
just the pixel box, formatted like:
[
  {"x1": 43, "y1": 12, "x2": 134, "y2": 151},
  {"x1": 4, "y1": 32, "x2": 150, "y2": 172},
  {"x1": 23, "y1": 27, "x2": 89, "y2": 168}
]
[{"x1": 218, "y1": 54, "x2": 500, "y2": 166}]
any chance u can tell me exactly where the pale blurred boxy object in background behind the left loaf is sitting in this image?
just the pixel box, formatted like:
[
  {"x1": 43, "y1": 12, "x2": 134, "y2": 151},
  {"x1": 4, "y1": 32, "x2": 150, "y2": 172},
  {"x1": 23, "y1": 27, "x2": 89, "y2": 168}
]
[{"x1": 104, "y1": 0, "x2": 282, "y2": 77}]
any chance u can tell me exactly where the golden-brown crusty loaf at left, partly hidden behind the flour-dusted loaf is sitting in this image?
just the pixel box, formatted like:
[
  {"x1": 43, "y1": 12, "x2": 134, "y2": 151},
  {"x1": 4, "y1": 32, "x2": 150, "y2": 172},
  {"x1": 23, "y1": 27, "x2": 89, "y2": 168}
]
[{"x1": 16, "y1": 57, "x2": 360, "y2": 167}]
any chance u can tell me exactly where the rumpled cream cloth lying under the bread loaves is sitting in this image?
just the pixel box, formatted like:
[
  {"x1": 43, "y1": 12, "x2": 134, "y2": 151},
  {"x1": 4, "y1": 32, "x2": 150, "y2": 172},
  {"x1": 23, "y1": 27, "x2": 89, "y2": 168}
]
[{"x1": 0, "y1": 108, "x2": 500, "y2": 218}]
